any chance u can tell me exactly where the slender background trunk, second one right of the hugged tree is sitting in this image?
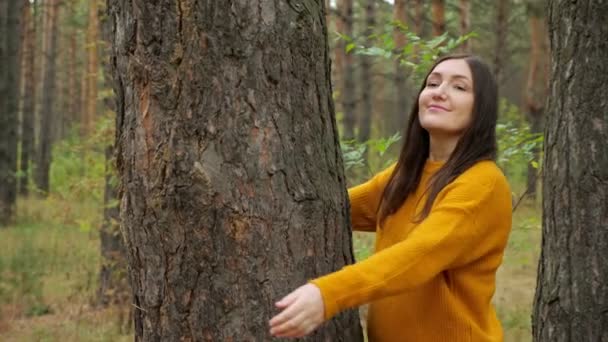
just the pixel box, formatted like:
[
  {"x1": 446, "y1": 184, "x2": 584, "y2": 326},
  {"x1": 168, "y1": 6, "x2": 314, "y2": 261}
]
[{"x1": 359, "y1": 0, "x2": 376, "y2": 150}]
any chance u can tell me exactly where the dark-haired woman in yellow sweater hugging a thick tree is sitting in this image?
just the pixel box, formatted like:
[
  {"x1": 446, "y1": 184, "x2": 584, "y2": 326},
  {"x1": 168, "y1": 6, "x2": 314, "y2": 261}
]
[{"x1": 270, "y1": 55, "x2": 511, "y2": 342}]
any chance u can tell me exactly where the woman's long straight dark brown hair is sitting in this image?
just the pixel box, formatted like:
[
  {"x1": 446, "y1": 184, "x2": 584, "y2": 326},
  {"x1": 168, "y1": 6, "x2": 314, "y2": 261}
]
[{"x1": 378, "y1": 54, "x2": 498, "y2": 225}]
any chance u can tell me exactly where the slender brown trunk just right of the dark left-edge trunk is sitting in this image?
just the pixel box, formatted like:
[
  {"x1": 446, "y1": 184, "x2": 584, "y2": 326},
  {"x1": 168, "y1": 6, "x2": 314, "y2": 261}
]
[{"x1": 19, "y1": 0, "x2": 37, "y2": 196}]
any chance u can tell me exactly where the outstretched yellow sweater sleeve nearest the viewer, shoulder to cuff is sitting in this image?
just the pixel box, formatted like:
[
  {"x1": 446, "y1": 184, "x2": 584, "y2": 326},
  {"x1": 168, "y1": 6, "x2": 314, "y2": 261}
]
[{"x1": 311, "y1": 176, "x2": 510, "y2": 319}]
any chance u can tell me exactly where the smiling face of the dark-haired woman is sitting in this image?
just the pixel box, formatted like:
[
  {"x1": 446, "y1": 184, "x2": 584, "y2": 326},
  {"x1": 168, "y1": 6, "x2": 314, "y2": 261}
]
[{"x1": 418, "y1": 59, "x2": 475, "y2": 137}]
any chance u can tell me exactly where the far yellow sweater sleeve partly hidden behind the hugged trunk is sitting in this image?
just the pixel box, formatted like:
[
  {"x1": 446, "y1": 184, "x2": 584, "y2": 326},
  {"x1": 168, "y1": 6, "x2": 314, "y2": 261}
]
[{"x1": 348, "y1": 165, "x2": 395, "y2": 232}]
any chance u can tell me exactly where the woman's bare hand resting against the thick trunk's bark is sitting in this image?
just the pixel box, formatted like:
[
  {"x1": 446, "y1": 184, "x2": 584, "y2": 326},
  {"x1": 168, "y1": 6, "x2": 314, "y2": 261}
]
[{"x1": 270, "y1": 284, "x2": 325, "y2": 337}]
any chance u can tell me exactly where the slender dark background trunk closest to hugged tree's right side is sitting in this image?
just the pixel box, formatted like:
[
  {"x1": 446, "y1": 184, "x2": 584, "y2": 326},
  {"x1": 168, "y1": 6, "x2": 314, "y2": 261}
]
[{"x1": 338, "y1": 0, "x2": 357, "y2": 140}]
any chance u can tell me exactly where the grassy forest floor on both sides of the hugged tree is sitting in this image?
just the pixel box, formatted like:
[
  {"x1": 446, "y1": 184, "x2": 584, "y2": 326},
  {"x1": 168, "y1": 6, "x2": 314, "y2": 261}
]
[{"x1": 0, "y1": 199, "x2": 541, "y2": 342}]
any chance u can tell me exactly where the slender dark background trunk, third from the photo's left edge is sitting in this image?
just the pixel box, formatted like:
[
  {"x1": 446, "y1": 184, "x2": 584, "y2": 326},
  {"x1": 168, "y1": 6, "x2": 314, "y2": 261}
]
[{"x1": 35, "y1": 0, "x2": 58, "y2": 193}]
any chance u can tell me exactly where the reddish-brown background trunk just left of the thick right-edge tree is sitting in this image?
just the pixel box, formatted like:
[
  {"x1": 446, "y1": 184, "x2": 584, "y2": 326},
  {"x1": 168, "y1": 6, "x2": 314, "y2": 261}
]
[{"x1": 523, "y1": 1, "x2": 549, "y2": 198}]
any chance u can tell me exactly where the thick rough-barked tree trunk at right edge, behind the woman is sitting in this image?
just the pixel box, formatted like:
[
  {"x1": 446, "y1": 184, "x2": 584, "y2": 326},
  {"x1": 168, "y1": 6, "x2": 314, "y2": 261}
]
[{"x1": 532, "y1": 0, "x2": 608, "y2": 342}]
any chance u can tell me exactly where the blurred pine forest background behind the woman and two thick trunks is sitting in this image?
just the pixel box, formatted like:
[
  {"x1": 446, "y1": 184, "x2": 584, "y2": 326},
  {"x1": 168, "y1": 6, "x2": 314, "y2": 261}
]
[{"x1": 0, "y1": 0, "x2": 549, "y2": 341}]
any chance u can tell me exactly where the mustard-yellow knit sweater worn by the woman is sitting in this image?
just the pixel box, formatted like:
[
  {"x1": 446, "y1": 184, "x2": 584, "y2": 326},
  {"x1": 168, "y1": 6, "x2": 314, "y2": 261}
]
[{"x1": 312, "y1": 161, "x2": 511, "y2": 342}]
